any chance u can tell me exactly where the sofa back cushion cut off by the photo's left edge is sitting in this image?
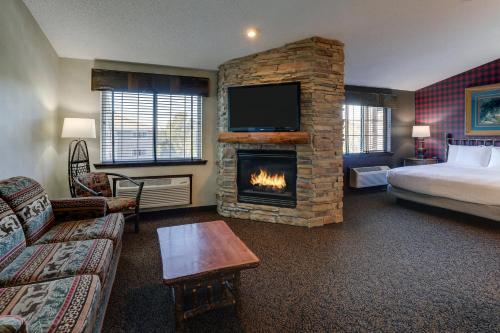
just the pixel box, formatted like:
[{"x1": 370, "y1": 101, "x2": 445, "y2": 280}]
[{"x1": 0, "y1": 199, "x2": 26, "y2": 270}]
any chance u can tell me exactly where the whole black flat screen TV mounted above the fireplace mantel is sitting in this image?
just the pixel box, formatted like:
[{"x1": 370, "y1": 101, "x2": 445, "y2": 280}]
[{"x1": 228, "y1": 82, "x2": 300, "y2": 132}]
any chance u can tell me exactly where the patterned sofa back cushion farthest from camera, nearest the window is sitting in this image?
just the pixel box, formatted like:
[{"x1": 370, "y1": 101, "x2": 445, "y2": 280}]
[{"x1": 0, "y1": 177, "x2": 54, "y2": 244}]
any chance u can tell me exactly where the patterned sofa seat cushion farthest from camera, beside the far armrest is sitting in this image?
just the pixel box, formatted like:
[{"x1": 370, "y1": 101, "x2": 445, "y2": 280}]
[{"x1": 37, "y1": 214, "x2": 124, "y2": 247}]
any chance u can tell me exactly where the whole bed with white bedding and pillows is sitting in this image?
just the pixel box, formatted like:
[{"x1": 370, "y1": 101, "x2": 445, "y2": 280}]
[{"x1": 387, "y1": 134, "x2": 500, "y2": 221}]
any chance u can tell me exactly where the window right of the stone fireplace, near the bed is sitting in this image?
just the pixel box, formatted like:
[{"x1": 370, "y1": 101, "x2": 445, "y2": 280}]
[{"x1": 342, "y1": 105, "x2": 391, "y2": 154}]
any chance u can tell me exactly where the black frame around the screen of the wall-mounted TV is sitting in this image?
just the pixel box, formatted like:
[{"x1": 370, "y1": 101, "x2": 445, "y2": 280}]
[{"x1": 227, "y1": 81, "x2": 301, "y2": 132}]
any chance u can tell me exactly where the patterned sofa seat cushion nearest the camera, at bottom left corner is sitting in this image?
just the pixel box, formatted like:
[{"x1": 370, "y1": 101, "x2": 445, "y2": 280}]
[{"x1": 0, "y1": 275, "x2": 101, "y2": 332}]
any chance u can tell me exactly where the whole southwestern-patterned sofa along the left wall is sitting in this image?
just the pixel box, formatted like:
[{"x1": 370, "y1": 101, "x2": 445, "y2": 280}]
[{"x1": 0, "y1": 177, "x2": 124, "y2": 333}]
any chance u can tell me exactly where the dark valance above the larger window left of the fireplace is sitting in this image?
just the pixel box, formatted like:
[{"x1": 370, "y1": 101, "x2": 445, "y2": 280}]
[{"x1": 91, "y1": 69, "x2": 209, "y2": 97}]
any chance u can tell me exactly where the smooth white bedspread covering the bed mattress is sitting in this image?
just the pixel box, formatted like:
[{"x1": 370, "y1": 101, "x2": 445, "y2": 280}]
[{"x1": 387, "y1": 163, "x2": 500, "y2": 206}]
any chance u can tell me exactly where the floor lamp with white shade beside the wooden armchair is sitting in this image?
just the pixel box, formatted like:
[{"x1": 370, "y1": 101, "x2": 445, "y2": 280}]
[{"x1": 61, "y1": 118, "x2": 96, "y2": 198}]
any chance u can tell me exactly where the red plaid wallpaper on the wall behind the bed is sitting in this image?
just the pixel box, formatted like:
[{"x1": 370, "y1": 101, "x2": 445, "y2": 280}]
[{"x1": 415, "y1": 59, "x2": 500, "y2": 159}]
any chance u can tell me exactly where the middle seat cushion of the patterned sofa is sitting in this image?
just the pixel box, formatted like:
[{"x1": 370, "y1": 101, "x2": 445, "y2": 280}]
[{"x1": 0, "y1": 239, "x2": 113, "y2": 287}]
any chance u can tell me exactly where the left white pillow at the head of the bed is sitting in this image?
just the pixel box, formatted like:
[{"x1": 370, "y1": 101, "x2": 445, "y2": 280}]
[{"x1": 448, "y1": 145, "x2": 491, "y2": 167}]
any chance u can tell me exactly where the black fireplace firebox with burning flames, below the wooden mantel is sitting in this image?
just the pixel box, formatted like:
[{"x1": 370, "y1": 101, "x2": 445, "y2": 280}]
[{"x1": 237, "y1": 150, "x2": 297, "y2": 207}]
